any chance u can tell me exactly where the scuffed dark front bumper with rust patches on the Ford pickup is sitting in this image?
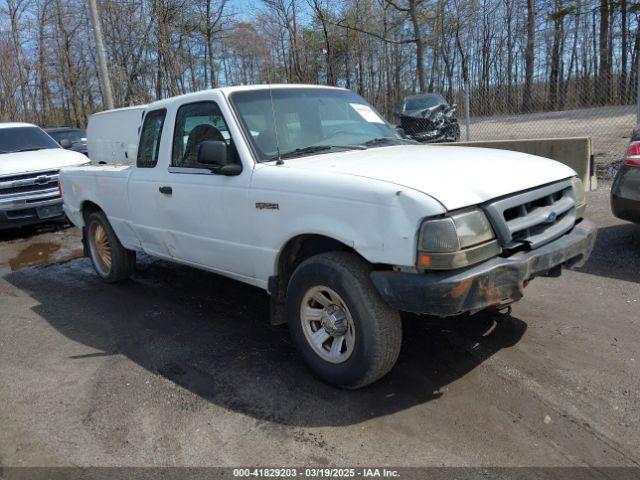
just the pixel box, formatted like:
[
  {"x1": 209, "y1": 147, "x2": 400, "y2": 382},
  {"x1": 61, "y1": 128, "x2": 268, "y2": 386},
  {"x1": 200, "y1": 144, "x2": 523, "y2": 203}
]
[{"x1": 371, "y1": 220, "x2": 596, "y2": 317}]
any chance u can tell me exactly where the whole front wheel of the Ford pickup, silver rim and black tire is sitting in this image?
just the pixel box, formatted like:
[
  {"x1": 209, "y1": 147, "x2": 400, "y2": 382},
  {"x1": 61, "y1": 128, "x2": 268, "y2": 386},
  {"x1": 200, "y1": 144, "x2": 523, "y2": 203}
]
[{"x1": 287, "y1": 252, "x2": 402, "y2": 388}]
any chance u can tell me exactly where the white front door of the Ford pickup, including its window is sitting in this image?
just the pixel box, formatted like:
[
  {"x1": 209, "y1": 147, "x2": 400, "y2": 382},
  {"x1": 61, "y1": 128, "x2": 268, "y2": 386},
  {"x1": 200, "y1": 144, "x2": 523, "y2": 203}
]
[{"x1": 156, "y1": 100, "x2": 254, "y2": 279}]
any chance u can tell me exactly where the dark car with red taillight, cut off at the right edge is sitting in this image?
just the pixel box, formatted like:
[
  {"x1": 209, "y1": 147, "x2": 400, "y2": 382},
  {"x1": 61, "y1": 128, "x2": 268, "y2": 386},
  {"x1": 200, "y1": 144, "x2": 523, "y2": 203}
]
[{"x1": 611, "y1": 126, "x2": 640, "y2": 223}]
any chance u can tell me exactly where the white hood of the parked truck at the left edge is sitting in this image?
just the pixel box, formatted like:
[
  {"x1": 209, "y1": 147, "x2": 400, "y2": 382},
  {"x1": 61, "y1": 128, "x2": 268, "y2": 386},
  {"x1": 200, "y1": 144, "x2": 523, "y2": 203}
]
[{"x1": 0, "y1": 148, "x2": 89, "y2": 177}]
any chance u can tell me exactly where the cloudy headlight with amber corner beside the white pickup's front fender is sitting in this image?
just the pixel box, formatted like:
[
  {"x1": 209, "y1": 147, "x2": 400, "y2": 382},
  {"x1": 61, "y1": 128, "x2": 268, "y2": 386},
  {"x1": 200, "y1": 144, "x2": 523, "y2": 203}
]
[{"x1": 418, "y1": 208, "x2": 500, "y2": 270}]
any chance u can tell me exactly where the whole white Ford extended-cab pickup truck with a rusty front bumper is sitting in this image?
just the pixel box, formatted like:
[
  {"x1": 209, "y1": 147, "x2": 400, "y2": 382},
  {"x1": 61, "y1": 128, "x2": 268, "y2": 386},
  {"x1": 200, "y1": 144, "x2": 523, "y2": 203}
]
[{"x1": 60, "y1": 85, "x2": 595, "y2": 388}]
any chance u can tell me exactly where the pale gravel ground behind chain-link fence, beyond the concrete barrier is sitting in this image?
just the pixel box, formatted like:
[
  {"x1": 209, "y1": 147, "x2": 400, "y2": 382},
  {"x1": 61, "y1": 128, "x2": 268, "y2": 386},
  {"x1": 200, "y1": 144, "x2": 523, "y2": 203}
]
[{"x1": 470, "y1": 105, "x2": 636, "y2": 172}]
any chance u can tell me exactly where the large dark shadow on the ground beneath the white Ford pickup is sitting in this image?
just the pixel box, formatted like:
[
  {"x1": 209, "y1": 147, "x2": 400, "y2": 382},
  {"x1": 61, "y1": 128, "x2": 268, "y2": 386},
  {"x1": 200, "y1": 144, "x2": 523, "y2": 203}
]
[{"x1": 5, "y1": 257, "x2": 527, "y2": 427}]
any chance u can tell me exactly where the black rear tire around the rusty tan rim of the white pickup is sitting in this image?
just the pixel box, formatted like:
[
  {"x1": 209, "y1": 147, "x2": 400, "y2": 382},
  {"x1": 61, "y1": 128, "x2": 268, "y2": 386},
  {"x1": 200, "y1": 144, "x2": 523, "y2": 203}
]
[{"x1": 85, "y1": 212, "x2": 136, "y2": 283}]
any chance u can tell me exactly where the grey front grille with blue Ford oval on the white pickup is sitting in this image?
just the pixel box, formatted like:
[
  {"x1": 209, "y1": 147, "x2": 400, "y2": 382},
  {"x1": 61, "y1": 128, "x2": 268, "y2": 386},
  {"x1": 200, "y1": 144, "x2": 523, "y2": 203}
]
[{"x1": 484, "y1": 180, "x2": 576, "y2": 249}]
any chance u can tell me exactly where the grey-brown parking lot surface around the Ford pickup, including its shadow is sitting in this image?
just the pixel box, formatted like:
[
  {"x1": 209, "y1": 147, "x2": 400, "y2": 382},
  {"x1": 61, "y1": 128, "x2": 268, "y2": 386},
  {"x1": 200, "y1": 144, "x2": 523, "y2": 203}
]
[{"x1": 0, "y1": 184, "x2": 640, "y2": 466}]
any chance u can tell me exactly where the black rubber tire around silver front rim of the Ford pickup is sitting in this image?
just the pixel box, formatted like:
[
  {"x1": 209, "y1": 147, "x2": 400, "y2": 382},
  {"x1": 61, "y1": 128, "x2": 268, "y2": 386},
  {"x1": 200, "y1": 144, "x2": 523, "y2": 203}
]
[{"x1": 286, "y1": 252, "x2": 402, "y2": 389}]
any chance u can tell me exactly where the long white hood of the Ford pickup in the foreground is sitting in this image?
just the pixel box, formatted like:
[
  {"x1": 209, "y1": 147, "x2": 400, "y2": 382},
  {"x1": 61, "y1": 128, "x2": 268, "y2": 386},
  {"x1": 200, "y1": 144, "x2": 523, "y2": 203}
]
[{"x1": 285, "y1": 145, "x2": 576, "y2": 210}]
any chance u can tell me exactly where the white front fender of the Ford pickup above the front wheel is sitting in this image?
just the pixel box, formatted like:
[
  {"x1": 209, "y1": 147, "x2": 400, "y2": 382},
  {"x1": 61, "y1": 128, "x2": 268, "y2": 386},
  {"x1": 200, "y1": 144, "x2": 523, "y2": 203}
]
[{"x1": 249, "y1": 167, "x2": 445, "y2": 280}]
